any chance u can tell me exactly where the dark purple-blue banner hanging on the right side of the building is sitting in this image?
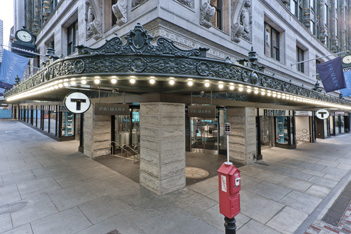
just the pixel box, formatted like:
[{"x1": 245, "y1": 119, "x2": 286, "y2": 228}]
[{"x1": 317, "y1": 57, "x2": 346, "y2": 92}]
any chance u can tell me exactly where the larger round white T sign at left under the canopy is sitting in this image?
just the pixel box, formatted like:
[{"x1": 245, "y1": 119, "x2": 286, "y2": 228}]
[{"x1": 64, "y1": 92, "x2": 90, "y2": 114}]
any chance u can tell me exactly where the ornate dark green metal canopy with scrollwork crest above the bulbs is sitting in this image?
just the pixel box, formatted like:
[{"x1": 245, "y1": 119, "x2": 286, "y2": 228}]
[{"x1": 5, "y1": 23, "x2": 351, "y2": 106}]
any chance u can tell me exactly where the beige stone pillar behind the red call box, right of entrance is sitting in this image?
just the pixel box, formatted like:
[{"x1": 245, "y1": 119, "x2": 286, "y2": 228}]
[{"x1": 227, "y1": 107, "x2": 256, "y2": 163}]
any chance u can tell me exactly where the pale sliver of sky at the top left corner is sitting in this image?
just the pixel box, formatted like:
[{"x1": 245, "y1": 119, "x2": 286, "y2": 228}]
[{"x1": 0, "y1": 0, "x2": 13, "y2": 49}]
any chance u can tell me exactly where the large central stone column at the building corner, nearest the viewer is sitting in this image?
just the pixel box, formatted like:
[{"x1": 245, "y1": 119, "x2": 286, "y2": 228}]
[{"x1": 140, "y1": 102, "x2": 185, "y2": 195}]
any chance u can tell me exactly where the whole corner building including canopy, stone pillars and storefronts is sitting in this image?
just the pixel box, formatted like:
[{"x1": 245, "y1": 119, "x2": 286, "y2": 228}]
[{"x1": 6, "y1": 0, "x2": 351, "y2": 194}]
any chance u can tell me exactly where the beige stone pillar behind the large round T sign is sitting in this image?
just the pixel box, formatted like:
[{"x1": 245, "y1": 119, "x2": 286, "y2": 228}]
[{"x1": 83, "y1": 104, "x2": 111, "y2": 158}]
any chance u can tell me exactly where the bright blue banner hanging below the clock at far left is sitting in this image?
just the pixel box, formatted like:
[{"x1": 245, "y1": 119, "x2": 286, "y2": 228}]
[{"x1": 0, "y1": 50, "x2": 29, "y2": 89}]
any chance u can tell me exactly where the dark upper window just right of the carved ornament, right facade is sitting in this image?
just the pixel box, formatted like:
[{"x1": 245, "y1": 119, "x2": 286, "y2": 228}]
[{"x1": 264, "y1": 23, "x2": 280, "y2": 61}]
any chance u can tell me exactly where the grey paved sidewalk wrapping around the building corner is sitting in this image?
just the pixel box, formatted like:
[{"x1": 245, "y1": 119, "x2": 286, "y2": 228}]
[{"x1": 0, "y1": 120, "x2": 351, "y2": 234}]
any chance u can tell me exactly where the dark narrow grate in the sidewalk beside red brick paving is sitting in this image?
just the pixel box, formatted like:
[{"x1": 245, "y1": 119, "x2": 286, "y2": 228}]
[{"x1": 322, "y1": 182, "x2": 351, "y2": 226}]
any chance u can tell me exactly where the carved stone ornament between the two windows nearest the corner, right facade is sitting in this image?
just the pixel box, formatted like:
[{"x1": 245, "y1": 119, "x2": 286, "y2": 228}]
[{"x1": 231, "y1": 0, "x2": 252, "y2": 43}]
